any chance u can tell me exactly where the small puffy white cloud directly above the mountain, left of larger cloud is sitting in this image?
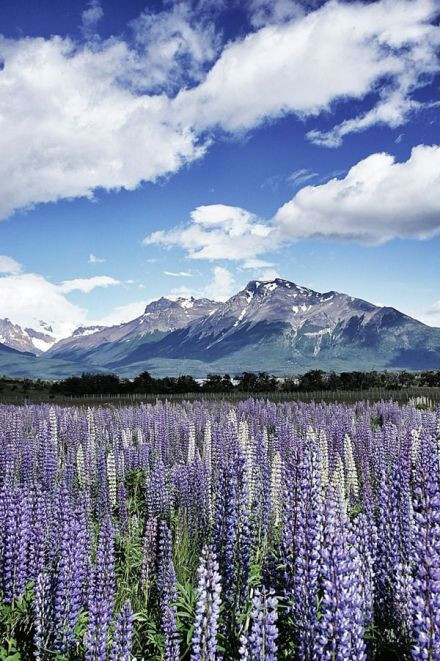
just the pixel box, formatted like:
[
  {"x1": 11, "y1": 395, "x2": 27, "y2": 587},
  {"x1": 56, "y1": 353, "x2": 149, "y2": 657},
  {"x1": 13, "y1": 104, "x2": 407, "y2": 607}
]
[{"x1": 143, "y1": 204, "x2": 273, "y2": 261}]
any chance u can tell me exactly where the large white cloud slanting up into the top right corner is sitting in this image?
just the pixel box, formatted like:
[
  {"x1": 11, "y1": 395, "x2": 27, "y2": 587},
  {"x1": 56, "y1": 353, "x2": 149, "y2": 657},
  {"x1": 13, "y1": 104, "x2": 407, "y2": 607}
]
[{"x1": 174, "y1": 0, "x2": 439, "y2": 131}]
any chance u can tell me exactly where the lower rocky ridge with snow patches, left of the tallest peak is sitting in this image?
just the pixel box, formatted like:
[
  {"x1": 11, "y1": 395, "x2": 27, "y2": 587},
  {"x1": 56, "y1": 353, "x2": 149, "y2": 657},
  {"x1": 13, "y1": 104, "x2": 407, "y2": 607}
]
[{"x1": 47, "y1": 297, "x2": 221, "y2": 366}]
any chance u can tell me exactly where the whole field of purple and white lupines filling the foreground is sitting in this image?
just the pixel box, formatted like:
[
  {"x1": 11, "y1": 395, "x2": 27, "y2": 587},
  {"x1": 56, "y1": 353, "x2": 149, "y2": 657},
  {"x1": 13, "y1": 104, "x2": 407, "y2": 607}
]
[{"x1": 0, "y1": 400, "x2": 440, "y2": 661}]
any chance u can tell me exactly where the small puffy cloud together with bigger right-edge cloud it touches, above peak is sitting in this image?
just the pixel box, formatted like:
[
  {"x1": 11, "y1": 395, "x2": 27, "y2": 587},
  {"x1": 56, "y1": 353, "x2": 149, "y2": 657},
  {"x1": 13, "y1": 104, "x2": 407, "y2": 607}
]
[{"x1": 144, "y1": 145, "x2": 440, "y2": 260}]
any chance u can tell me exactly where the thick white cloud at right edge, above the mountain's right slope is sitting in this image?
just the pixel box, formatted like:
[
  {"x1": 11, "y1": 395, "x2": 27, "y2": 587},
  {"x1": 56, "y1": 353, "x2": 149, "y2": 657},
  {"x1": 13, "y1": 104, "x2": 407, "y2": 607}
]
[{"x1": 273, "y1": 145, "x2": 440, "y2": 244}]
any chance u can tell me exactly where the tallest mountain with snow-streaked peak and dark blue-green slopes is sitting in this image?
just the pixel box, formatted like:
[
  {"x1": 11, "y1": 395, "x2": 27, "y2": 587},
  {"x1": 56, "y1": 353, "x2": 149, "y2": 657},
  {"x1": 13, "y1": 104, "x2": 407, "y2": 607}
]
[{"x1": 111, "y1": 279, "x2": 440, "y2": 374}]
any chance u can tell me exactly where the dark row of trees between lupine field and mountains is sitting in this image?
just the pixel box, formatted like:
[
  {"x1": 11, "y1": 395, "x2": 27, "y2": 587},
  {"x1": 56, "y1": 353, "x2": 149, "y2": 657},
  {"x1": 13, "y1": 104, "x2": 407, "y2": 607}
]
[{"x1": 50, "y1": 370, "x2": 440, "y2": 396}]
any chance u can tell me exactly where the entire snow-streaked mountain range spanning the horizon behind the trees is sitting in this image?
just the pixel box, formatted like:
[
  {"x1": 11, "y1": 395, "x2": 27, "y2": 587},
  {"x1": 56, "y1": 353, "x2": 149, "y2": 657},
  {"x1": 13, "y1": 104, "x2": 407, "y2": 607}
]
[{"x1": 0, "y1": 278, "x2": 440, "y2": 378}]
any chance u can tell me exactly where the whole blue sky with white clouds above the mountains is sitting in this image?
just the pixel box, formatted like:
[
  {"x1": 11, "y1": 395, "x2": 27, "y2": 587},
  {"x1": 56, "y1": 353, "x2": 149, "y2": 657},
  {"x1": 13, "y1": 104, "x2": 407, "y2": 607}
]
[{"x1": 0, "y1": 0, "x2": 440, "y2": 337}]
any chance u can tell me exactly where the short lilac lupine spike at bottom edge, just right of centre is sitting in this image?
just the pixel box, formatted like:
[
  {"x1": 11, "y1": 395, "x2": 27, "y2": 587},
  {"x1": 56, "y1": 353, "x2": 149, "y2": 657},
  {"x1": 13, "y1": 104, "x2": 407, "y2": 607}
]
[{"x1": 240, "y1": 587, "x2": 278, "y2": 661}]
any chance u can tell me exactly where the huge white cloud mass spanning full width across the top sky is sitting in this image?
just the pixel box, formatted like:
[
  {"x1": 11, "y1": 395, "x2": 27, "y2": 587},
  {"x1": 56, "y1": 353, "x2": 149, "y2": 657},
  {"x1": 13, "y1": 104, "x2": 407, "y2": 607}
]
[{"x1": 0, "y1": 0, "x2": 439, "y2": 222}]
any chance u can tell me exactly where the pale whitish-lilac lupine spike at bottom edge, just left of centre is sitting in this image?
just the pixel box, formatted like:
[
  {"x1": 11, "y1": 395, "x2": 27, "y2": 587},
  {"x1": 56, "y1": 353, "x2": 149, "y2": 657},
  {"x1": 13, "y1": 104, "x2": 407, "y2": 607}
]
[{"x1": 191, "y1": 547, "x2": 221, "y2": 661}]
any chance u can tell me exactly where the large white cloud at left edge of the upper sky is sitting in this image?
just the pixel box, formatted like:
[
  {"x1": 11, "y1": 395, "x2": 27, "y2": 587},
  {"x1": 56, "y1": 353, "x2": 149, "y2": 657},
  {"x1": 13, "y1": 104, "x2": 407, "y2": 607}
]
[{"x1": 0, "y1": 37, "x2": 204, "y2": 218}]
